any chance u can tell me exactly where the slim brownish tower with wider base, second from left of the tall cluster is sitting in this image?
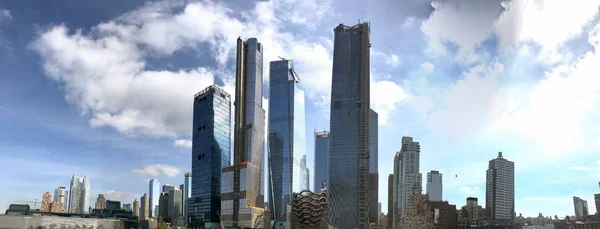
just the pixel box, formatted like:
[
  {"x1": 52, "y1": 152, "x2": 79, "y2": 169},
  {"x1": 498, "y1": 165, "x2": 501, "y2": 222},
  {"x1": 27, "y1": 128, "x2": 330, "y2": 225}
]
[{"x1": 220, "y1": 38, "x2": 265, "y2": 228}]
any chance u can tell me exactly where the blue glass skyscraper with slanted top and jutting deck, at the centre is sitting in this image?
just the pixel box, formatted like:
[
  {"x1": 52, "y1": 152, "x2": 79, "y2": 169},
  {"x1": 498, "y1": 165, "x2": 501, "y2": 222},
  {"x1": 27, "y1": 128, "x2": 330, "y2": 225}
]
[{"x1": 267, "y1": 59, "x2": 309, "y2": 221}]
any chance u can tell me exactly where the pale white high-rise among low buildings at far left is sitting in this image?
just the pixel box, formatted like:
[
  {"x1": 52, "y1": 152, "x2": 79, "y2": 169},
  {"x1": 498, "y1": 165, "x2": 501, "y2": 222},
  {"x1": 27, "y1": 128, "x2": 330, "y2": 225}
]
[{"x1": 69, "y1": 173, "x2": 90, "y2": 214}]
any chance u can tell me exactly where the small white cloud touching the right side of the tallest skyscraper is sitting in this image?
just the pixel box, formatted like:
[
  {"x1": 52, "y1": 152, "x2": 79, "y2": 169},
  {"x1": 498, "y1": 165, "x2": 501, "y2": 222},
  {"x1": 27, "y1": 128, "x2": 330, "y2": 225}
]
[{"x1": 371, "y1": 81, "x2": 408, "y2": 125}]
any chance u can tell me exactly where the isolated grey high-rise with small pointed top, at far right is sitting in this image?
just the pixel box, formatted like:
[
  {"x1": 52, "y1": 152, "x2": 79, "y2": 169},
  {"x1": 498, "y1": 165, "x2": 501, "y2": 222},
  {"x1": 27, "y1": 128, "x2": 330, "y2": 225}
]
[{"x1": 485, "y1": 152, "x2": 515, "y2": 224}]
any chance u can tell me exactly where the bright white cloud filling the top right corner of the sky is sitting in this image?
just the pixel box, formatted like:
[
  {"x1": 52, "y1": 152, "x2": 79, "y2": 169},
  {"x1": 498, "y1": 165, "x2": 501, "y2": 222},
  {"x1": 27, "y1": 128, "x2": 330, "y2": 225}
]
[{"x1": 494, "y1": 0, "x2": 600, "y2": 49}]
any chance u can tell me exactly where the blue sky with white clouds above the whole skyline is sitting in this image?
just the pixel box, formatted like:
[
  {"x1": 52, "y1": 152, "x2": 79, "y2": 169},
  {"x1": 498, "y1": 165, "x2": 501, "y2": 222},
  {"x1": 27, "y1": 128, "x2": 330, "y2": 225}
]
[{"x1": 0, "y1": 0, "x2": 600, "y2": 217}]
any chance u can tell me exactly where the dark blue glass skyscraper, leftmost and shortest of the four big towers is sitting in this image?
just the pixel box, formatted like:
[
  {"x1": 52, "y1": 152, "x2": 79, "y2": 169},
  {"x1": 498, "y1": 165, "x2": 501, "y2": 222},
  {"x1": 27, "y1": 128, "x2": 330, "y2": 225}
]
[{"x1": 186, "y1": 85, "x2": 231, "y2": 228}]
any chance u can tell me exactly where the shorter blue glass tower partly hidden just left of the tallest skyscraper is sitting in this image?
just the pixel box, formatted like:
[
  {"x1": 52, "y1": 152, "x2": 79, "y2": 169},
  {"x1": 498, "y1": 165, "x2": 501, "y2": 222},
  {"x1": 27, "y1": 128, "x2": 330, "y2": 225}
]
[{"x1": 313, "y1": 131, "x2": 329, "y2": 192}]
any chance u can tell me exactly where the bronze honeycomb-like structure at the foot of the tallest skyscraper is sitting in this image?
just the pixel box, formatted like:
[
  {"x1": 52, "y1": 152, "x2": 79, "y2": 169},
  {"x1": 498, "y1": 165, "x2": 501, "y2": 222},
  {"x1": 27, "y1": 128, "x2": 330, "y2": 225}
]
[{"x1": 290, "y1": 190, "x2": 329, "y2": 229}]
